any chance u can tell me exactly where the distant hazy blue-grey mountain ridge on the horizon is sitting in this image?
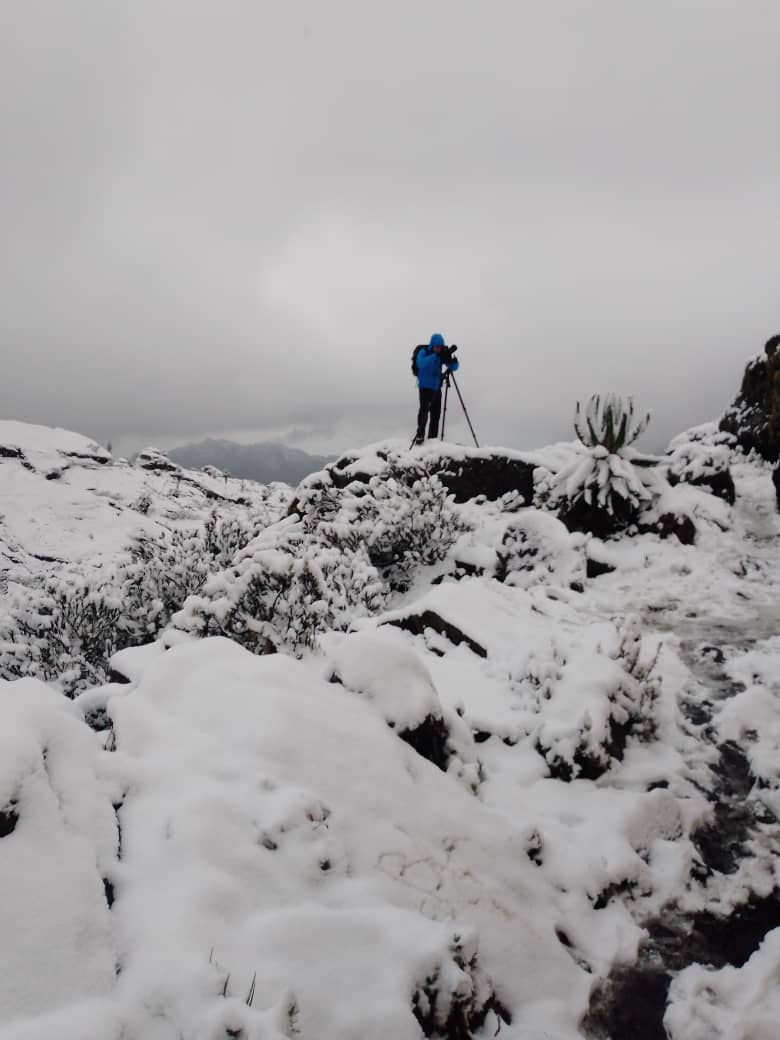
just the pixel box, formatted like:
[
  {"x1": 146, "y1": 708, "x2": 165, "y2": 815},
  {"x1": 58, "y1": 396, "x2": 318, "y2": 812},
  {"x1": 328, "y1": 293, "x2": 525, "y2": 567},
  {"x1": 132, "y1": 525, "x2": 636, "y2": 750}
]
[{"x1": 166, "y1": 437, "x2": 335, "y2": 486}]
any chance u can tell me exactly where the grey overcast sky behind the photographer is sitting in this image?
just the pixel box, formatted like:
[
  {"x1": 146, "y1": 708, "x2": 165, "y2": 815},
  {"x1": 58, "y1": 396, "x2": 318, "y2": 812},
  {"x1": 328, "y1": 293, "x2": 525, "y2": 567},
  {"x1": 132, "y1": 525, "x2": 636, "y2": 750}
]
[{"x1": 0, "y1": 0, "x2": 780, "y2": 450}]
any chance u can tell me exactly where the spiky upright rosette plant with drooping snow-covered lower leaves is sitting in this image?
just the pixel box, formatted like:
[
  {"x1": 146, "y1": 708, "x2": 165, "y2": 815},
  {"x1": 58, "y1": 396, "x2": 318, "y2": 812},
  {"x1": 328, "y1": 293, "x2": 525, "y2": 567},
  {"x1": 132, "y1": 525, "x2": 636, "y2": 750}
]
[{"x1": 537, "y1": 394, "x2": 658, "y2": 537}]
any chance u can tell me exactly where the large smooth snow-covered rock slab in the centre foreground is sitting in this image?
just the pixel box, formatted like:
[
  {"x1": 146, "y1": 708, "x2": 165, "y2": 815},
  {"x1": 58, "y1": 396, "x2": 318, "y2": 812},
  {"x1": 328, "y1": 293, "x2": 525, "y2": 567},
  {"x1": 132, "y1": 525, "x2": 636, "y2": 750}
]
[{"x1": 99, "y1": 640, "x2": 576, "y2": 1038}]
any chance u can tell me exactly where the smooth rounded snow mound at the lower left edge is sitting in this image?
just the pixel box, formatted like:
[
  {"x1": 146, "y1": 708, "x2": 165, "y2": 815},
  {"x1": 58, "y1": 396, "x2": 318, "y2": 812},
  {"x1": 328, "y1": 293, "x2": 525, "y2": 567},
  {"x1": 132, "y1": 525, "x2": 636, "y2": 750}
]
[{"x1": 0, "y1": 679, "x2": 118, "y2": 1022}]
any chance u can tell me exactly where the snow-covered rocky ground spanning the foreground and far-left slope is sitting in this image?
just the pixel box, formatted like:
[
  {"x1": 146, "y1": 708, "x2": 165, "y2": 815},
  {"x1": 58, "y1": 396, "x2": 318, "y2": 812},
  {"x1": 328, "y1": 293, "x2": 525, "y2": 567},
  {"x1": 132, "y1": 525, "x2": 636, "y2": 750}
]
[{"x1": 0, "y1": 430, "x2": 780, "y2": 1040}]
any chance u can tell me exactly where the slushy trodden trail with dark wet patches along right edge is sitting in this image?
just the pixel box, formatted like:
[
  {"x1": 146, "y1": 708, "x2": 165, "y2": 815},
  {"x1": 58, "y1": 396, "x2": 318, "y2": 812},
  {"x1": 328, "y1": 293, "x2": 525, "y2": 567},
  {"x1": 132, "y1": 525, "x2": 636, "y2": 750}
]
[{"x1": 582, "y1": 465, "x2": 780, "y2": 1040}]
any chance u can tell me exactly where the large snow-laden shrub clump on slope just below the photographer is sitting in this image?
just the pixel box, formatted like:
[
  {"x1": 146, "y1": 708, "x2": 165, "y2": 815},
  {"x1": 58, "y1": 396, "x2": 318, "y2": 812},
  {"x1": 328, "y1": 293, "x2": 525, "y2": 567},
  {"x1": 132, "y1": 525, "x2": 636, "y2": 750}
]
[{"x1": 175, "y1": 460, "x2": 462, "y2": 653}]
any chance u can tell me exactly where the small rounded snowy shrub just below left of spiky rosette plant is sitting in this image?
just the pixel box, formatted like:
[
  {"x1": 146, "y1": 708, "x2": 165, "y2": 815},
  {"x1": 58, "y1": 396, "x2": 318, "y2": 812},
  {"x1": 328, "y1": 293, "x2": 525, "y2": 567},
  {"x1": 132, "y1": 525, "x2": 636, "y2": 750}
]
[{"x1": 495, "y1": 509, "x2": 586, "y2": 589}]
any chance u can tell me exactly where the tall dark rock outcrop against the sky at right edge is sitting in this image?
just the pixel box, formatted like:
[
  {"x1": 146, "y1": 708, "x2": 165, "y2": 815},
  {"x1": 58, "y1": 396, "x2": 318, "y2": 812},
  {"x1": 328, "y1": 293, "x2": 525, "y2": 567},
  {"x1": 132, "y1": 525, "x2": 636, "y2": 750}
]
[{"x1": 720, "y1": 335, "x2": 780, "y2": 462}]
